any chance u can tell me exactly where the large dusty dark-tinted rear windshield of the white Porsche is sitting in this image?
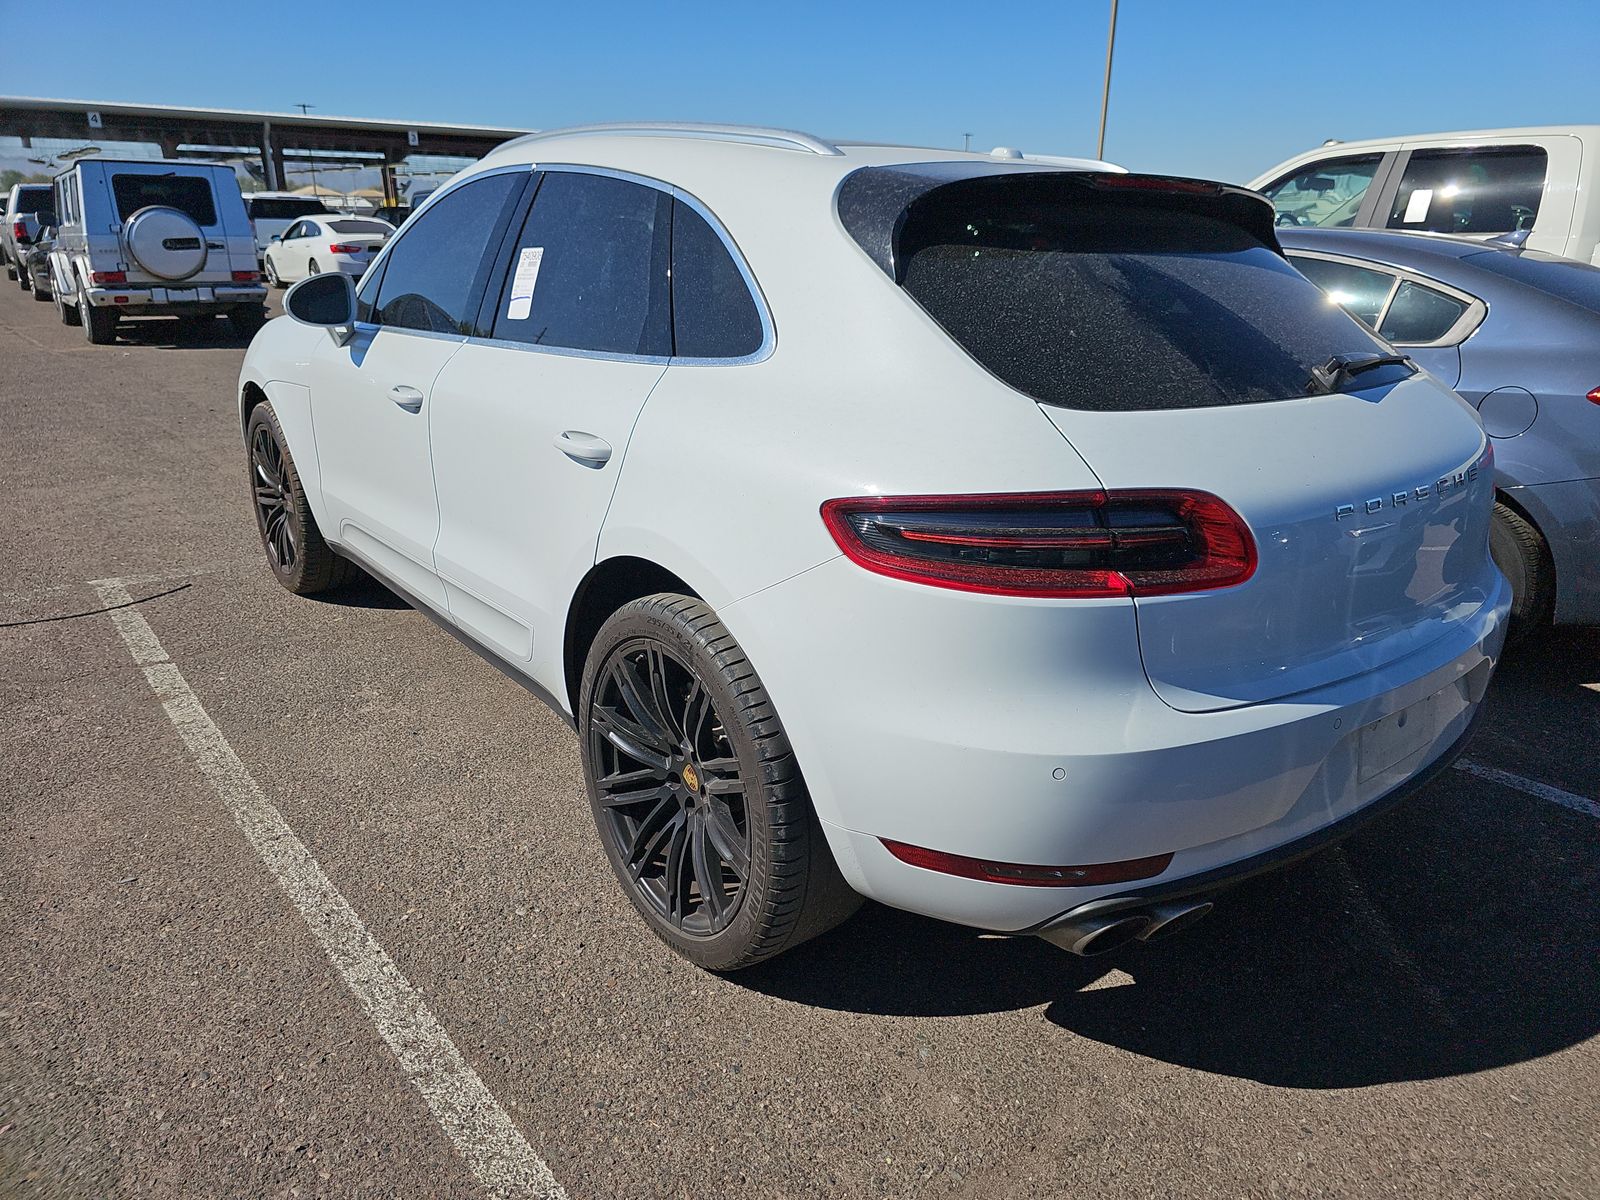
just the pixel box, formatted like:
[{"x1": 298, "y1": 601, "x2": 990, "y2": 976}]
[{"x1": 894, "y1": 174, "x2": 1410, "y2": 411}]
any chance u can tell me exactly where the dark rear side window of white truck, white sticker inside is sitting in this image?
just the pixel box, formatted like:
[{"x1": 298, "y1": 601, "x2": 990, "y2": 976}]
[{"x1": 1389, "y1": 146, "x2": 1546, "y2": 234}]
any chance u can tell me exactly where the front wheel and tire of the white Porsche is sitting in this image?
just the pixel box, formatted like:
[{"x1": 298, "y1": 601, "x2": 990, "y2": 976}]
[{"x1": 245, "y1": 402, "x2": 350, "y2": 595}]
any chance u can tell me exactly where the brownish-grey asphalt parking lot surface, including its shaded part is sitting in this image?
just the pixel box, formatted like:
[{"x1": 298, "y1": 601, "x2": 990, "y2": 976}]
[{"x1": 0, "y1": 282, "x2": 1600, "y2": 1200}]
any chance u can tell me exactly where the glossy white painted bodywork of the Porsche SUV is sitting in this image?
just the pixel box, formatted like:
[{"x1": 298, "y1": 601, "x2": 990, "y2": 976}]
[{"x1": 242, "y1": 136, "x2": 1509, "y2": 931}]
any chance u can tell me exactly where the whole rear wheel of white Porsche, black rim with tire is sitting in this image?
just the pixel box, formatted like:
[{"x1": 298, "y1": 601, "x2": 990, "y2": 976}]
[{"x1": 578, "y1": 594, "x2": 861, "y2": 971}]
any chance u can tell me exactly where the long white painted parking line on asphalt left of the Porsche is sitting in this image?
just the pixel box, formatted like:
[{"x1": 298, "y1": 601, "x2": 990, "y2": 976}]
[{"x1": 91, "y1": 579, "x2": 566, "y2": 1200}]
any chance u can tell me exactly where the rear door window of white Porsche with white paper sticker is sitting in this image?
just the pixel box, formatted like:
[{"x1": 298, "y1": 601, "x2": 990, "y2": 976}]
[{"x1": 483, "y1": 171, "x2": 672, "y2": 357}]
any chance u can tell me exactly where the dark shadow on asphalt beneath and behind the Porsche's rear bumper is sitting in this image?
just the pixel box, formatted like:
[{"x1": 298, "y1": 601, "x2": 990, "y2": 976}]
[{"x1": 733, "y1": 773, "x2": 1600, "y2": 1088}]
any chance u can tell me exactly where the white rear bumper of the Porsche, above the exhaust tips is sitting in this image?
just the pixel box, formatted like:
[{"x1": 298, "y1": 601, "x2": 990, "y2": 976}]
[{"x1": 722, "y1": 560, "x2": 1510, "y2": 933}]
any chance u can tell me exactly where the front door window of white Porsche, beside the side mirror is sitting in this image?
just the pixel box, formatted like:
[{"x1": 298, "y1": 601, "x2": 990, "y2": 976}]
[{"x1": 371, "y1": 173, "x2": 525, "y2": 333}]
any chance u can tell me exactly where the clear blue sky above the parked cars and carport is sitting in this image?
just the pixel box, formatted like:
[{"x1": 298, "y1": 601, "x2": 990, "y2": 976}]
[{"x1": 0, "y1": 0, "x2": 1600, "y2": 181}]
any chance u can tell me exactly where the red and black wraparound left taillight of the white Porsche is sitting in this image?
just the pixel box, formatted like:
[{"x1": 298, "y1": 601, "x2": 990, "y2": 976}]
[{"x1": 822, "y1": 488, "x2": 1256, "y2": 598}]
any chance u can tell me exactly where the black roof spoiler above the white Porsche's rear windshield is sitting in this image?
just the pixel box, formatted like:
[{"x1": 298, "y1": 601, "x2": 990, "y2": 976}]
[{"x1": 835, "y1": 162, "x2": 1283, "y2": 283}]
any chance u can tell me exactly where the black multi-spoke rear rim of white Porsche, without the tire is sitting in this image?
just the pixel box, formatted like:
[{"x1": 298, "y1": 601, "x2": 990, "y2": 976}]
[{"x1": 589, "y1": 638, "x2": 750, "y2": 938}]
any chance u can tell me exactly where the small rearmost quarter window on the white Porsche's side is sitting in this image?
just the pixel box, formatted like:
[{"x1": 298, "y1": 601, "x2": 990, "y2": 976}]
[{"x1": 672, "y1": 200, "x2": 762, "y2": 358}]
